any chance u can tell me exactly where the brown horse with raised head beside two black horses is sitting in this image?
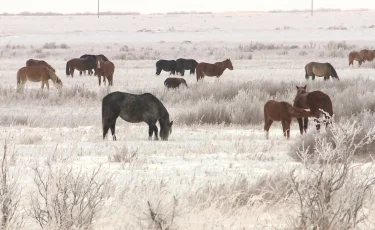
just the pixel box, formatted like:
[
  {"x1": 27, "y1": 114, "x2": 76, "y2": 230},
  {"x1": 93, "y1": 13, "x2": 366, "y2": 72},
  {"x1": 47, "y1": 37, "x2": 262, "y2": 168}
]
[{"x1": 195, "y1": 59, "x2": 233, "y2": 81}]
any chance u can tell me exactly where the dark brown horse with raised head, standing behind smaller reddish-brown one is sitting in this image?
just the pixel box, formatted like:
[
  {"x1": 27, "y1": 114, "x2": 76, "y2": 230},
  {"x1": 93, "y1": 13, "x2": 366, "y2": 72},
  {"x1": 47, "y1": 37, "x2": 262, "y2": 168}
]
[{"x1": 294, "y1": 85, "x2": 333, "y2": 134}]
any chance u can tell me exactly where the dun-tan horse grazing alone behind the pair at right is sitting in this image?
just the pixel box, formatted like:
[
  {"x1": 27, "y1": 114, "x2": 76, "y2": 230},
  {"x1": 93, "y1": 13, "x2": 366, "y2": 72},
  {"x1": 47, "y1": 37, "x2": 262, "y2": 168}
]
[{"x1": 305, "y1": 62, "x2": 340, "y2": 80}]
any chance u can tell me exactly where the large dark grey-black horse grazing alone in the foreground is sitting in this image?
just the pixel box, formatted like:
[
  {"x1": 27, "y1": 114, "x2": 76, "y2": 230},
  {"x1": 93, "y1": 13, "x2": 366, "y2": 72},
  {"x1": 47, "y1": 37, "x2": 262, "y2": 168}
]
[{"x1": 102, "y1": 91, "x2": 173, "y2": 140}]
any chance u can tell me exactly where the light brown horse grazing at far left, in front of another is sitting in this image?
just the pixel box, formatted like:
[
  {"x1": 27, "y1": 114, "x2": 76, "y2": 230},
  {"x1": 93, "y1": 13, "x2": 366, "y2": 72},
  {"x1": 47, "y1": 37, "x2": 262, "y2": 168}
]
[{"x1": 17, "y1": 66, "x2": 63, "y2": 89}]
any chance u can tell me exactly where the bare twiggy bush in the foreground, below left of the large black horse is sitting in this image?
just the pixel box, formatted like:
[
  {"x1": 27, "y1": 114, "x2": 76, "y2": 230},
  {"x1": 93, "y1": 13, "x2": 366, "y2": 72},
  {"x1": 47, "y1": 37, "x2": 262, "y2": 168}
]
[{"x1": 28, "y1": 165, "x2": 111, "y2": 229}]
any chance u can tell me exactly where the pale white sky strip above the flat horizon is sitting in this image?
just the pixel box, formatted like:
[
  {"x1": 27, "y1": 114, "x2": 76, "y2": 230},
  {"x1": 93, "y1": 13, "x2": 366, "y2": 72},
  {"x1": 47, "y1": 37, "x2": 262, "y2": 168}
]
[{"x1": 0, "y1": 0, "x2": 375, "y2": 13}]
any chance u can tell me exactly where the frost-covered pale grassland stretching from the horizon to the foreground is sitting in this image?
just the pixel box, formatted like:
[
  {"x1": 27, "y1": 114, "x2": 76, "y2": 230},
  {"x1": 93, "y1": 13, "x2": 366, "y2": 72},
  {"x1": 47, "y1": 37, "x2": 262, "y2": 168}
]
[{"x1": 0, "y1": 11, "x2": 375, "y2": 229}]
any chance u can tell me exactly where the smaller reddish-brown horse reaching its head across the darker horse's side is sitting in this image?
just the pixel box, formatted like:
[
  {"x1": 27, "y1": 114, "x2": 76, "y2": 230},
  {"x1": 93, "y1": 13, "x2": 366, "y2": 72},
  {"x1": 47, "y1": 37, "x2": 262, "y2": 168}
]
[{"x1": 264, "y1": 100, "x2": 311, "y2": 139}]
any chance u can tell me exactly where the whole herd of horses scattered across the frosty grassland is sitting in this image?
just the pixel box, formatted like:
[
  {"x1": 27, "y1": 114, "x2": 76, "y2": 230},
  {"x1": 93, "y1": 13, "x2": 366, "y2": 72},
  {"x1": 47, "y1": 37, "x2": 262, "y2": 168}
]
[{"x1": 17, "y1": 50, "x2": 375, "y2": 140}]
